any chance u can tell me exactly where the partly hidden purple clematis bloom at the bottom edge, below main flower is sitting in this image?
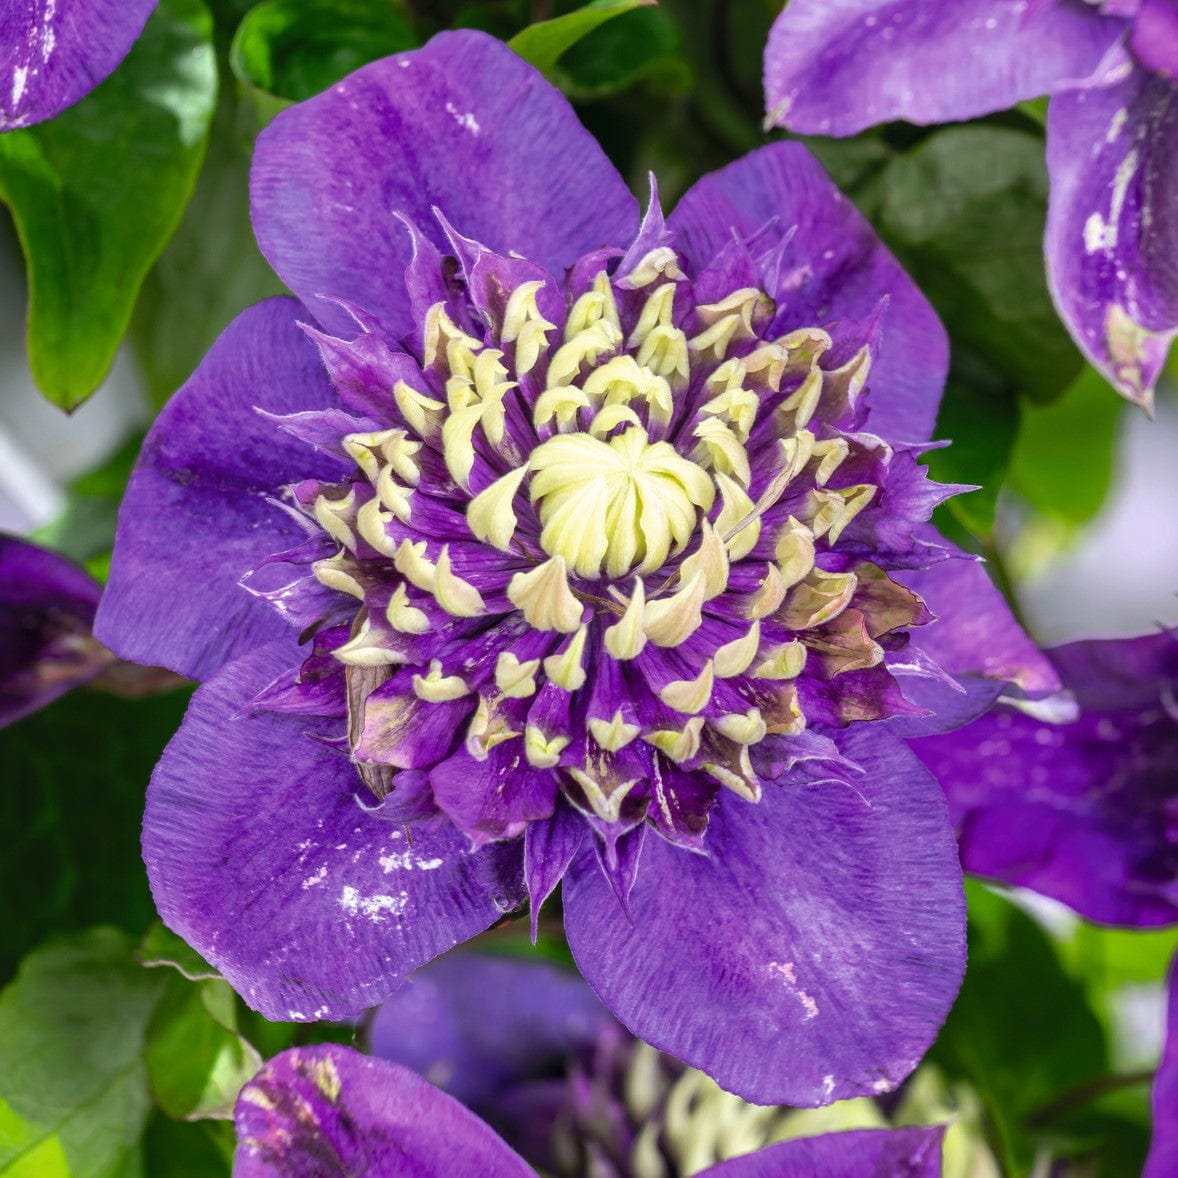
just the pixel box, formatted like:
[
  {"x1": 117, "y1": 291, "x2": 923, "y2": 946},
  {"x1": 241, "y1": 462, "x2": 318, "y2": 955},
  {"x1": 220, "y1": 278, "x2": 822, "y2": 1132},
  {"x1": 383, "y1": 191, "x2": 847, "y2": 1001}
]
[{"x1": 234, "y1": 954, "x2": 942, "y2": 1178}]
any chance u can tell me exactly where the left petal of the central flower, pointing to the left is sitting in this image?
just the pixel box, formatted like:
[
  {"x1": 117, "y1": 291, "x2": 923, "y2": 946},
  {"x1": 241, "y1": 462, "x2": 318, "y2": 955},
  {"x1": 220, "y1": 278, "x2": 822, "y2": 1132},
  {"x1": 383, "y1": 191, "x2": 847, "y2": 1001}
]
[{"x1": 94, "y1": 298, "x2": 339, "y2": 680}]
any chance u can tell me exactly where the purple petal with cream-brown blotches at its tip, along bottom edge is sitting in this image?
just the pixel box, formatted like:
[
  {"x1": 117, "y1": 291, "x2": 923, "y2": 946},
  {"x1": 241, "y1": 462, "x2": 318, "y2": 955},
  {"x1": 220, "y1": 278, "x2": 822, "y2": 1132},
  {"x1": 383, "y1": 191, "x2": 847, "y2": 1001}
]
[{"x1": 233, "y1": 1044, "x2": 535, "y2": 1178}]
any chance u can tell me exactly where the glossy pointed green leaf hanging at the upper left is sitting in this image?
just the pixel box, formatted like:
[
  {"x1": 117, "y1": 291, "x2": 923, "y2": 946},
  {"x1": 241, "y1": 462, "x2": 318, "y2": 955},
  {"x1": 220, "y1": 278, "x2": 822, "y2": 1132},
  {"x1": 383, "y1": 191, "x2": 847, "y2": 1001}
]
[{"x1": 0, "y1": 0, "x2": 217, "y2": 409}]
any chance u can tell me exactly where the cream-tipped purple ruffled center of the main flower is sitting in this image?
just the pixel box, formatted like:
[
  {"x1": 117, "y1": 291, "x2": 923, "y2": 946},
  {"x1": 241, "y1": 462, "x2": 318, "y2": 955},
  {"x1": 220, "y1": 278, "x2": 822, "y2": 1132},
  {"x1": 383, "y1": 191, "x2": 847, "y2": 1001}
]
[{"x1": 292, "y1": 221, "x2": 942, "y2": 846}]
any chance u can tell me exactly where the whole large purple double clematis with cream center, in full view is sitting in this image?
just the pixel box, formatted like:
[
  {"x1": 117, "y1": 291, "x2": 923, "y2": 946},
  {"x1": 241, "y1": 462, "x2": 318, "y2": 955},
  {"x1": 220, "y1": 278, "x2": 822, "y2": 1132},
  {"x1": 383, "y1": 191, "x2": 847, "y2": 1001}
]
[{"x1": 97, "y1": 32, "x2": 1058, "y2": 1104}]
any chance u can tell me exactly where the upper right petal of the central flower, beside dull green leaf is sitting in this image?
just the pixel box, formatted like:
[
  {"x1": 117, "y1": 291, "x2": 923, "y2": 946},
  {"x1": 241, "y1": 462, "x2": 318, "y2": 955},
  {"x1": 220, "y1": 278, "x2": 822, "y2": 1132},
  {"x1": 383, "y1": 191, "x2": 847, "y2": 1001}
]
[{"x1": 669, "y1": 143, "x2": 948, "y2": 442}]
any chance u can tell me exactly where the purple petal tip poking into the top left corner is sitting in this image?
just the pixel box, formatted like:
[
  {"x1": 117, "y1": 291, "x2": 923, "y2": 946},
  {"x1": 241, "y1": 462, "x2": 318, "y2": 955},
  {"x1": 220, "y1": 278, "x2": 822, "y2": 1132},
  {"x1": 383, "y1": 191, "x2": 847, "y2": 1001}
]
[{"x1": 0, "y1": 0, "x2": 157, "y2": 131}]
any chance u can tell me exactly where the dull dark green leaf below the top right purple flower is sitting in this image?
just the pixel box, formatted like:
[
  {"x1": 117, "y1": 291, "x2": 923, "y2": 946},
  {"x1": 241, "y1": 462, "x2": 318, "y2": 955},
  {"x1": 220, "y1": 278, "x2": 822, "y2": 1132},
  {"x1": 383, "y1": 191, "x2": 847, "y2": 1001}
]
[{"x1": 874, "y1": 125, "x2": 1081, "y2": 401}]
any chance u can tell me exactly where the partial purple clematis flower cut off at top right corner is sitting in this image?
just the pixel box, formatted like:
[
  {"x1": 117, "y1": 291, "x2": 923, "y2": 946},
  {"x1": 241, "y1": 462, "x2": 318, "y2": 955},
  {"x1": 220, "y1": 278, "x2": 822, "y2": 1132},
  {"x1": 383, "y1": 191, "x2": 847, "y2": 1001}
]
[{"x1": 765, "y1": 0, "x2": 1178, "y2": 408}]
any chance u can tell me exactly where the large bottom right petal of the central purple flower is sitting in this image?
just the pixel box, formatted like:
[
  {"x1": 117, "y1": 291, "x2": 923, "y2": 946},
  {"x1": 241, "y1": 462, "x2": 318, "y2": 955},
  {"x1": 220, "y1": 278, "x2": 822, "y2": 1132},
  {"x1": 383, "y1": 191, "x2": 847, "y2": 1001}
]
[{"x1": 564, "y1": 730, "x2": 965, "y2": 1106}]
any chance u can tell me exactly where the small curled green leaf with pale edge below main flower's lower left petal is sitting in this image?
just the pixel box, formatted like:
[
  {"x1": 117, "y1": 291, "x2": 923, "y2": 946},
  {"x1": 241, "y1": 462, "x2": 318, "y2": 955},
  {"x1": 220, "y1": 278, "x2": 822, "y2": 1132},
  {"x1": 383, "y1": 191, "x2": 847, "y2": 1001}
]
[{"x1": 145, "y1": 974, "x2": 262, "y2": 1120}]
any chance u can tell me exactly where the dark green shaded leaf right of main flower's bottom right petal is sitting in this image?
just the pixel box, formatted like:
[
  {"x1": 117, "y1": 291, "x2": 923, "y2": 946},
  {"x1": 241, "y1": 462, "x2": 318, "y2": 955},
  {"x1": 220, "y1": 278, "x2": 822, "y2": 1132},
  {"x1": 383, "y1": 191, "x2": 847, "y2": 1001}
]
[{"x1": 928, "y1": 882, "x2": 1108, "y2": 1174}]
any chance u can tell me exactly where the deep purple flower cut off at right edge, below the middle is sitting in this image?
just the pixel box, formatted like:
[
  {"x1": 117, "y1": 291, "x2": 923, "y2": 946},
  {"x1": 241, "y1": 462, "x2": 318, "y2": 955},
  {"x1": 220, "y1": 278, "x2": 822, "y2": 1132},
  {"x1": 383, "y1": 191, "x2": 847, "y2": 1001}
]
[{"x1": 913, "y1": 634, "x2": 1178, "y2": 926}]
